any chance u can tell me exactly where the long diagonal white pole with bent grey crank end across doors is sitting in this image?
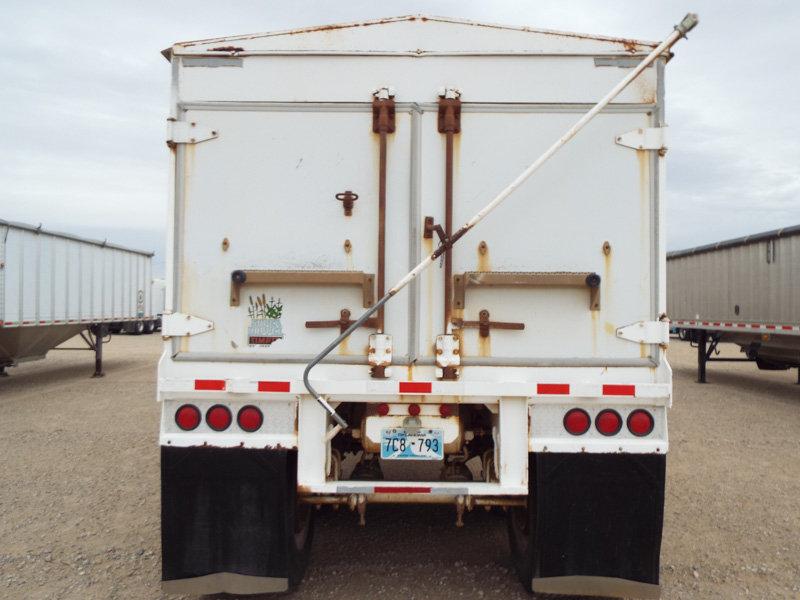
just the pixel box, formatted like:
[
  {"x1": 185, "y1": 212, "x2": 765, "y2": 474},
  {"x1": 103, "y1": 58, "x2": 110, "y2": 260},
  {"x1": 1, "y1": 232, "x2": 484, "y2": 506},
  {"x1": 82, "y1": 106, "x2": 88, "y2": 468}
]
[{"x1": 303, "y1": 13, "x2": 698, "y2": 439}]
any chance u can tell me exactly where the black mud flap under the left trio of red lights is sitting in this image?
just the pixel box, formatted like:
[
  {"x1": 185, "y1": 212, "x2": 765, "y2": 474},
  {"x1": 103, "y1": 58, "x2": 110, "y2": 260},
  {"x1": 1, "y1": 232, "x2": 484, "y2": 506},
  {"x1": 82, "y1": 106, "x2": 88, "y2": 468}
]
[{"x1": 161, "y1": 447, "x2": 311, "y2": 594}]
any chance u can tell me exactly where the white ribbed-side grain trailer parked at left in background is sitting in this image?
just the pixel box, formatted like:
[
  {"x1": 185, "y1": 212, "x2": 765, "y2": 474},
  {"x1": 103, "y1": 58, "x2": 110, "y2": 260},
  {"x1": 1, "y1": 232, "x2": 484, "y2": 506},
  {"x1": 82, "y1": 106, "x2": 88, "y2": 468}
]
[{"x1": 0, "y1": 221, "x2": 157, "y2": 376}]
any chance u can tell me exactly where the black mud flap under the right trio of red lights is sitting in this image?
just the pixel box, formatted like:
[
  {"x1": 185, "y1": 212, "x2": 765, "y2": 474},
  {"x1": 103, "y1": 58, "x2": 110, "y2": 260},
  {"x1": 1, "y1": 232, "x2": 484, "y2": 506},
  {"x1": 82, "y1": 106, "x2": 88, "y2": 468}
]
[{"x1": 509, "y1": 453, "x2": 666, "y2": 598}]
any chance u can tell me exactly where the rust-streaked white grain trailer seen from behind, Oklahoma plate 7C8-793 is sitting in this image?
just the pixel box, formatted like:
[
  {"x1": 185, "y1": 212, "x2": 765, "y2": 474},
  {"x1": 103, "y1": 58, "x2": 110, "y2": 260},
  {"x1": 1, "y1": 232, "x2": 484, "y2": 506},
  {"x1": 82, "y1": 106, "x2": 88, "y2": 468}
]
[{"x1": 158, "y1": 16, "x2": 693, "y2": 597}]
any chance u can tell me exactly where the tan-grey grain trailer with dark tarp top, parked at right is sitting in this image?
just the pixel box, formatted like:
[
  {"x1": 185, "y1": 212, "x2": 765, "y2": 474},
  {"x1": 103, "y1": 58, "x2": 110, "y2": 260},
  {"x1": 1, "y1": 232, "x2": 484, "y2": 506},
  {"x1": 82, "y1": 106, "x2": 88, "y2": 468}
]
[{"x1": 667, "y1": 225, "x2": 800, "y2": 383}]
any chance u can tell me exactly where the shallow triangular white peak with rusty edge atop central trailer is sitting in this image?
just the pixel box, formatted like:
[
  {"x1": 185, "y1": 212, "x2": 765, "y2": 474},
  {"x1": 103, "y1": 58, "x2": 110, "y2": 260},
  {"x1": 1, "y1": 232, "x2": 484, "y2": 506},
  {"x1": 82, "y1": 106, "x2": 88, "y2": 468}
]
[{"x1": 162, "y1": 15, "x2": 658, "y2": 60}]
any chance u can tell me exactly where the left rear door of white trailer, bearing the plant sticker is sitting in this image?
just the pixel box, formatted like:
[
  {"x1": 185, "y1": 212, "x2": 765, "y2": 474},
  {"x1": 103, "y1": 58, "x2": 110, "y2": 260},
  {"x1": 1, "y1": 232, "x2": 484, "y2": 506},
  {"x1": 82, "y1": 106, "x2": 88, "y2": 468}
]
[{"x1": 176, "y1": 104, "x2": 410, "y2": 362}]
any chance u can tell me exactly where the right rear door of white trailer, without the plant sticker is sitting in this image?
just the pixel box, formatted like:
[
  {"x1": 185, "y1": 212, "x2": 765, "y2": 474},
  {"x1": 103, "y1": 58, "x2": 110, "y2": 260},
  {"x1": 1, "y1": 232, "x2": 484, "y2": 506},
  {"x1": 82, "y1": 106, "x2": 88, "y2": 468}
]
[{"x1": 419, "y1": 102, "x2": 656, "y2": 364}]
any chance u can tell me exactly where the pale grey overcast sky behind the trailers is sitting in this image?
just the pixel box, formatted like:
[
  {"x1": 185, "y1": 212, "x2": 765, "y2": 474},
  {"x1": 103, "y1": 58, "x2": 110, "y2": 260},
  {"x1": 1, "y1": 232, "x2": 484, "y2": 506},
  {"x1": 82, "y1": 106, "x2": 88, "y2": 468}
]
[{"x1": 0, "y1": 0, "x2": 800, "y2": 272}]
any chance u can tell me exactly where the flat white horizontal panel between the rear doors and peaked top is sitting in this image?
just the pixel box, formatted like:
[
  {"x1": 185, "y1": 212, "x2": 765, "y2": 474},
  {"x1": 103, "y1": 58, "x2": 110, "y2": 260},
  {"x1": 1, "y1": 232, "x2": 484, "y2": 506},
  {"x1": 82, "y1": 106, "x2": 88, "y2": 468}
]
[{"x1": 180, "y1": 56, "x2": 656, "y2": 104}]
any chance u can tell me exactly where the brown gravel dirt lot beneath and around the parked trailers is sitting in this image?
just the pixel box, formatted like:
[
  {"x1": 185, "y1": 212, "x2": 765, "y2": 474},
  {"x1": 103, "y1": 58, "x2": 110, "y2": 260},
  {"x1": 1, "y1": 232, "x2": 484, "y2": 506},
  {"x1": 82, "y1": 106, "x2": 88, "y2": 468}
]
[{"x1": 0, "y1": 336, "x2": 800, "y2": 600}]
